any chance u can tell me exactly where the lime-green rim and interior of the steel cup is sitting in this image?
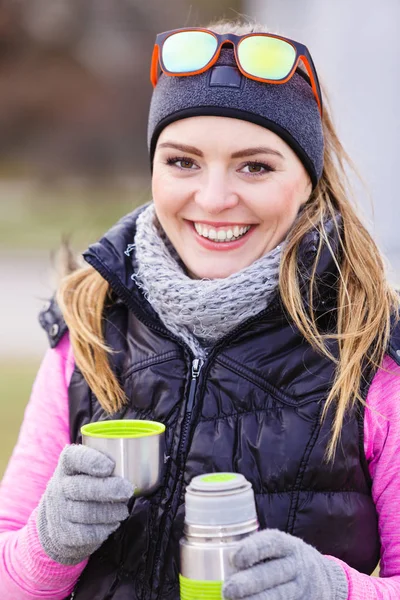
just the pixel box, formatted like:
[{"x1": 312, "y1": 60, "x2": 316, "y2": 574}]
[{"x1": 81, "y1": 419, "x2": 165, "y2": 439}]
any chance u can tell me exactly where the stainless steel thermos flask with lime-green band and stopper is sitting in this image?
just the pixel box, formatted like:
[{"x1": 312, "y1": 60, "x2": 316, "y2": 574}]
[{"x1": 179, "y1": 473, "x2": 258, "y2": 600}]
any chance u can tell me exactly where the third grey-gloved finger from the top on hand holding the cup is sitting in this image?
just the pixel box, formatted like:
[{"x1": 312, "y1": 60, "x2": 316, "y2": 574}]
[{"x1": 63, "y1": 500, "x2": 129, "y2": 525}]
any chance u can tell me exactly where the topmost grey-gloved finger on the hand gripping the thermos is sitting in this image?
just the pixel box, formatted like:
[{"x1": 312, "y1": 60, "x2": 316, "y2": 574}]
[{"x1": 232, "y1": 529, "x2": 297, "y2": 571}]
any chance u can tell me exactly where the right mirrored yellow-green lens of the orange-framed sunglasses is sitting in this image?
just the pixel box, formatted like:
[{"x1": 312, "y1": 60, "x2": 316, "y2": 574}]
[{"x1": 238, "y1": 35, "x2": 296, "y2": 81}]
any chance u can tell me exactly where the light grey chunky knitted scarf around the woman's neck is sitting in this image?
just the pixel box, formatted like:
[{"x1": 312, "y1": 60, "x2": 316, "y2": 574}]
[{"x1": 133, "y1": 204, "x2": 283, "y2": 358}]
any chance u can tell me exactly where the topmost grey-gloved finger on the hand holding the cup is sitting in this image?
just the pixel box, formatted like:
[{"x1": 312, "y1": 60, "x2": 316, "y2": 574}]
[{"x1": 59, "y1": 444, "x2": 115, "y2": 477}]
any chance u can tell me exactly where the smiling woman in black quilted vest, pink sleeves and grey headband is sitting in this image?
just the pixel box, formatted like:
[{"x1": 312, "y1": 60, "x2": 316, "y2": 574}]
[{"x1": 0, "y1": 18, "x2": 400, "y2": 600}]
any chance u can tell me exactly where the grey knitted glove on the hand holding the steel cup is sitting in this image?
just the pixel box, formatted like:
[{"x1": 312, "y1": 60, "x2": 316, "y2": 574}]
[{"x1": 36, "y1": 445, "x2": 134, "y2": 565}]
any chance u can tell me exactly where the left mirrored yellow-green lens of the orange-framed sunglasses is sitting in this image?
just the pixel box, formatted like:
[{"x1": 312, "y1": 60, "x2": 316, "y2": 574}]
[{"x1": 162, "y1": 31, "x2": 218, "y2": 73}]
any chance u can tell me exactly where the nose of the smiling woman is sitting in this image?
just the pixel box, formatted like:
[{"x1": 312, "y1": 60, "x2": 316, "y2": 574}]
[{"x1": 195, "y1": 172, "x2": 239, "y2": 215}]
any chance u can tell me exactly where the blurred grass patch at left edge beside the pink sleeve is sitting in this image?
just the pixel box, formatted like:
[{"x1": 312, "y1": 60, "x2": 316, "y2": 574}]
[{"x1": 0, "y1": 359, "x2": 40, "y2": 479}]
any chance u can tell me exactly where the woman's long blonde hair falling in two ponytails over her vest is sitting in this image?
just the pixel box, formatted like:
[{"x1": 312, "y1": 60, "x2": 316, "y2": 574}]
[{"x1": 57, "y1": 21, "x2": 399, "y2": 460}]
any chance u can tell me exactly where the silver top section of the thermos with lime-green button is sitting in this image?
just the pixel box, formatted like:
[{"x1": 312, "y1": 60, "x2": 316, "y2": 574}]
[{"x1": 185, "y1": 473, "x2": 257, "y2": 527}]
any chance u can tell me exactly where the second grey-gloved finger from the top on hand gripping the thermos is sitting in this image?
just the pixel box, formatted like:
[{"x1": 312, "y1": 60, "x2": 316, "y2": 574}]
[{"x1": 223, "y1": 557, "x2": 296, "y2": 599}]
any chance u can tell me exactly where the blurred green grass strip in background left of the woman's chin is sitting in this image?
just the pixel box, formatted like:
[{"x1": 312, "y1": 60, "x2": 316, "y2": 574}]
[{"x1": 0, "y1": 180, "x2": 151, "y2": 251}]
